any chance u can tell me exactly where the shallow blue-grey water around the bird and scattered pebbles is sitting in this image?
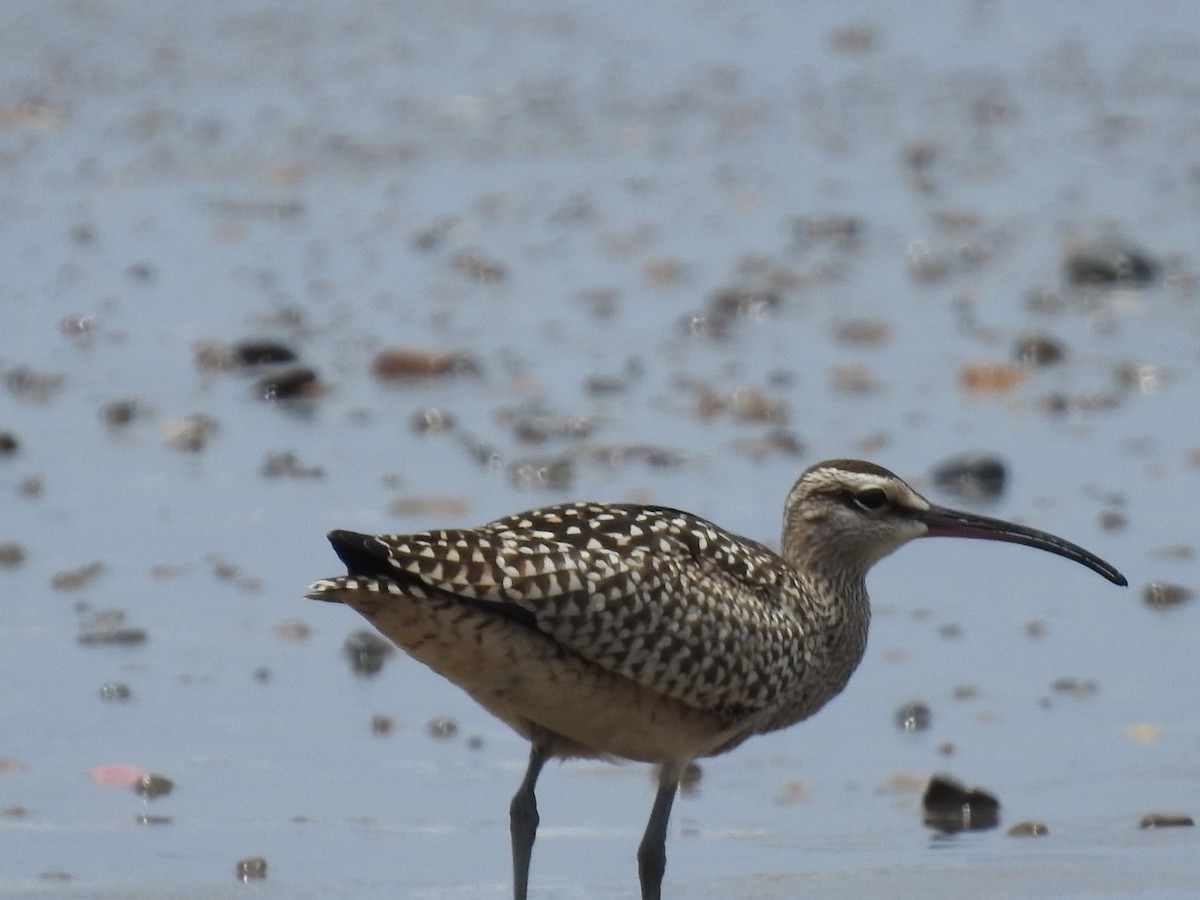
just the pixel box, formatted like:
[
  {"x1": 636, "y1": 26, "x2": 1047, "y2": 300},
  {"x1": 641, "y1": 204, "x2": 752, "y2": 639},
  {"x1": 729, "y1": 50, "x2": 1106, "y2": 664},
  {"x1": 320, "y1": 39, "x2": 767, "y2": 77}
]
[{"x1": 0, "y1": 0, "x2": 1200, "y2": 898}]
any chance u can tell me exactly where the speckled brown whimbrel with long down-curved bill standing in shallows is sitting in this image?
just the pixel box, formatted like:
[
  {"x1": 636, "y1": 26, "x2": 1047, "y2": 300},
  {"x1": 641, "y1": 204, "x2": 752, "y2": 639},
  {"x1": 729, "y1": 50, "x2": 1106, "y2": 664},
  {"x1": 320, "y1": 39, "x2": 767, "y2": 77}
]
[{"x1": 308, "y1": 460, "x2": 1127, "y2": 900}]
